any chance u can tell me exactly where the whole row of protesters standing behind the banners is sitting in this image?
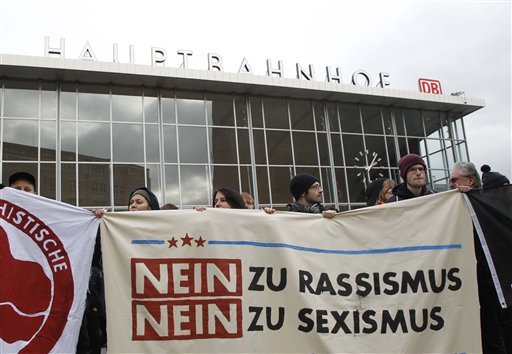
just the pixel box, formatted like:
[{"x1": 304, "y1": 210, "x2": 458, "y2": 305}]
[{"x1": 2, "y1": 154, "x2": 512, "y2": 354}]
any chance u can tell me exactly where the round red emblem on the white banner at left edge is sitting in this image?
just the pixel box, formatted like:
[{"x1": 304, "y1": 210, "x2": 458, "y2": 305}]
[{"x1": 0, "y1": 200, "x2": 74, "y2": 353}]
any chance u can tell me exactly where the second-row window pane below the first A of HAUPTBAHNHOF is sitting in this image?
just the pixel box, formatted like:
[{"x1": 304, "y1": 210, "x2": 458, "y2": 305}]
[{"x1": 78, "y1": 122, "x2": 110, "y2": 161}]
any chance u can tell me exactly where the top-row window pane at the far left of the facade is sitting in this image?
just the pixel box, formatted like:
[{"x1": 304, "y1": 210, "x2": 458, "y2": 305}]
[{"x1": 4, "y1": 81, "x2": 39, "y2": 118}]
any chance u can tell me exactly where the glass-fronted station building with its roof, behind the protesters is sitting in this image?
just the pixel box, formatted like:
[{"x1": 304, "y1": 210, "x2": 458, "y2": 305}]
[{"x1": 0, "y1": 38, "x2": 484, "y2": 210}]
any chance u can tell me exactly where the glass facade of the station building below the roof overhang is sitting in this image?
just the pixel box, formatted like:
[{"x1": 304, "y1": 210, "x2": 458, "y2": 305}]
[{"x1": 0, "y1": 78, "x2": 468, "y2": 210}]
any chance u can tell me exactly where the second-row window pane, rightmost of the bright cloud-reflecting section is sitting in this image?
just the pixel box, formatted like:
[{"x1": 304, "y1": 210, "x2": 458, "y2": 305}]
[{"x1": 178, "y1": 127, "x2": 208, "y2": 163}]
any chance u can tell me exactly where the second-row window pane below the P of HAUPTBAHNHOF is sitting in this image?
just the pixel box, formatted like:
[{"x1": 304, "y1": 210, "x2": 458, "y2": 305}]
[{"x1": 112, "y1": 123, "x2": 144, "y2": 162}]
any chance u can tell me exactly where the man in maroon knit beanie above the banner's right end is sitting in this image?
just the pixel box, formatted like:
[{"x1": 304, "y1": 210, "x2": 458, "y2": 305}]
[{"x1": 388, "y1": 154, "x2": 434, "y2": 203}]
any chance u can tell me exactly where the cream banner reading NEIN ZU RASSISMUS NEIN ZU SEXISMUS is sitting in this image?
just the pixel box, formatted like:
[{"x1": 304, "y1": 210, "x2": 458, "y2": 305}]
[{"x1": 101, "y1": 192, "x2": 481, "y2": 354}]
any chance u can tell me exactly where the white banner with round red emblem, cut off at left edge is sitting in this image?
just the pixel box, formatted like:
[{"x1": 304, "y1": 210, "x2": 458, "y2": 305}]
[{"x1": 0, "y1": 188, "x2": 99, "y2": 353}]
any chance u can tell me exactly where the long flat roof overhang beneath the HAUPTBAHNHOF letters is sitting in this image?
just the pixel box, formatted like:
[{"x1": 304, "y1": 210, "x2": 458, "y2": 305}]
[{"x1": 0, "y1": 54, "x2": 485, "y2": 116}]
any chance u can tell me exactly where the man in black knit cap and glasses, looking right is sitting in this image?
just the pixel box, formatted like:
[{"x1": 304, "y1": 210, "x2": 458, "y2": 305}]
[{"x1": 287, "y1": 173, "x2": 336, "y2": 218}]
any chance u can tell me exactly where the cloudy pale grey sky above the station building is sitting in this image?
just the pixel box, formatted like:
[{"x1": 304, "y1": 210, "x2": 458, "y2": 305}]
[{"x1": 0, "y1": 0, "x2": 512, "y2": 179}]
